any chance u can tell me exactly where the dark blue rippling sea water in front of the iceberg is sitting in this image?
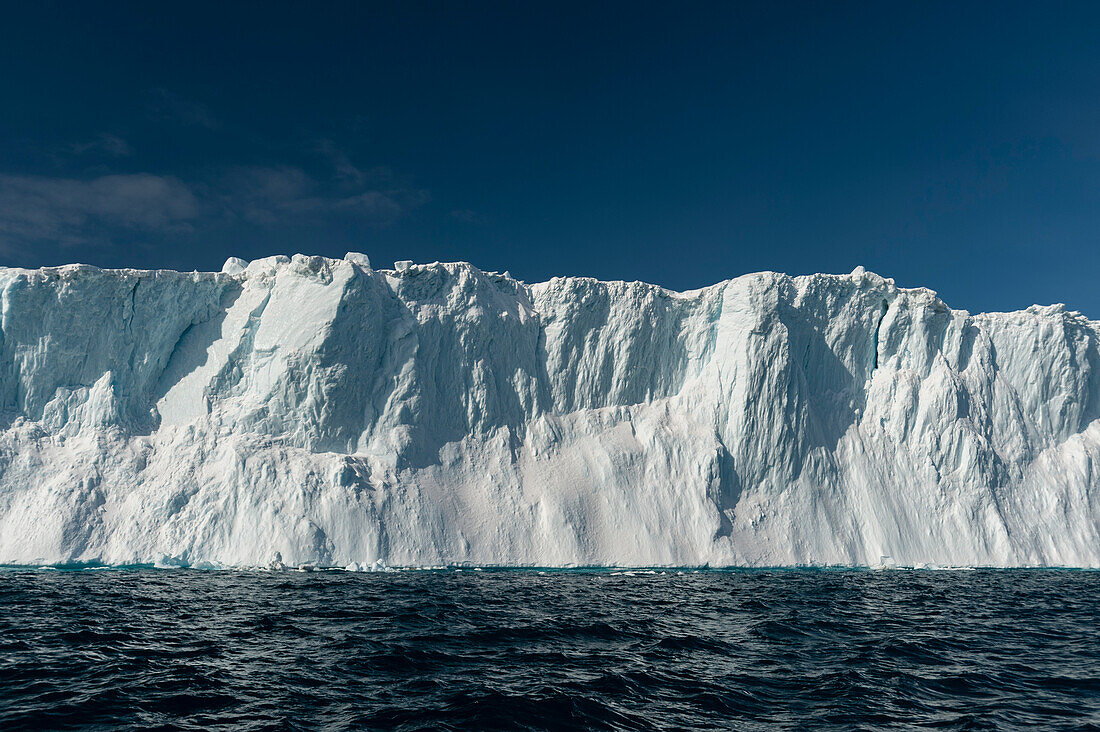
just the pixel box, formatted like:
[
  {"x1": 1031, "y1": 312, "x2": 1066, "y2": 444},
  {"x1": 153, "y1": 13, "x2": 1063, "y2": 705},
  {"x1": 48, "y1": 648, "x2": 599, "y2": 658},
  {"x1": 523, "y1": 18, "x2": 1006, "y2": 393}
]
[{"x1": 0, "y1": 570, "x2": 1100, "y2": 730}]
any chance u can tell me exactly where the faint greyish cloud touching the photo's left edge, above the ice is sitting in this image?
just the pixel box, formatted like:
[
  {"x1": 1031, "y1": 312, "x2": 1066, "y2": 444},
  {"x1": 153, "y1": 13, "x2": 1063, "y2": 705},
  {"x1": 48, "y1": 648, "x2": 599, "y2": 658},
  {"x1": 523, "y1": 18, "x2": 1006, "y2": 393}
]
[{"x1": 0, "y1": 173, "x2": 201, "y2": 252}]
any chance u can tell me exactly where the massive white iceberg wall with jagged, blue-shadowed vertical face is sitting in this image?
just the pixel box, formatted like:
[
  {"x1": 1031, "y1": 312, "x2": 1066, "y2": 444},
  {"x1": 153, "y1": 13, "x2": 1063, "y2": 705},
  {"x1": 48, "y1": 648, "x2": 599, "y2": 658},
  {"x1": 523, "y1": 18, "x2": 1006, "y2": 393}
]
[{"x1": 0, "y1": 254, "x2": 1100, "y2": 567}]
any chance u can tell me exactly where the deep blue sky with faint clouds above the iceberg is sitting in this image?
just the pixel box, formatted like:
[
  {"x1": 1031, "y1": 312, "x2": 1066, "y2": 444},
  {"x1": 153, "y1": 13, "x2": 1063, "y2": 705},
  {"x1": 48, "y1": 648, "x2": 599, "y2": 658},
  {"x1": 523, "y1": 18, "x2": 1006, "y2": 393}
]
[{"x1": 0, "y1": 0, "x2": 1100, "y2": 318}]
